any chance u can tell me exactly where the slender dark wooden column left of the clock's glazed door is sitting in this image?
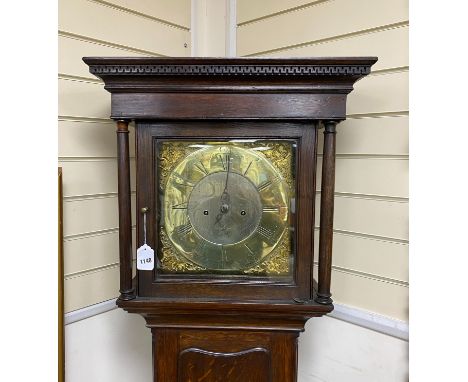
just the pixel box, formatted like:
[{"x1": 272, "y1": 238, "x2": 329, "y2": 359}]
[{"x1": 117, "y1": 120, "x2": 135, "y2": 300}]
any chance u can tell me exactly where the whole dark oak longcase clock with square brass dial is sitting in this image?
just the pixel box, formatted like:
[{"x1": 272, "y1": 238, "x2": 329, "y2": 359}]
[{"x1": 84, "y1": 57, "x2": 377, "y2": 382}]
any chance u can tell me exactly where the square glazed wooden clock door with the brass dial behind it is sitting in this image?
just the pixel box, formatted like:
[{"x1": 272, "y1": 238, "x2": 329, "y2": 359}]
[{"x1": 137, "y1": 122, "x2": 316, "y2": 299}]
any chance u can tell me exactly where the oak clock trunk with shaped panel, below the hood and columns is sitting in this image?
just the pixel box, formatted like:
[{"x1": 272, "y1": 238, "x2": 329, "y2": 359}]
[{"x1": 117, "y1": 298, "x2": 333, "y2": 382}]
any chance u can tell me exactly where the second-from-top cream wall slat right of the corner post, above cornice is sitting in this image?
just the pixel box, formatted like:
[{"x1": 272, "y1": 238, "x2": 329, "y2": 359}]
[{"x1": 237, "y1": 0, "x2": 408, "y2": 56}]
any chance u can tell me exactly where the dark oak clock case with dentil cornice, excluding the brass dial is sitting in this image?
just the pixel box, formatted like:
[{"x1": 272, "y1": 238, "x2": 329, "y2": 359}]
[{"x1": 83, "y1": 57, "x2": 377, "y2": 382}]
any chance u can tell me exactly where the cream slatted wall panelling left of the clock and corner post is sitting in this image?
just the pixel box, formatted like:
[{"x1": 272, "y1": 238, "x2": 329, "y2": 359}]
[{"x1": 58, "y1": 0, "x2": 191, "y2": 312}]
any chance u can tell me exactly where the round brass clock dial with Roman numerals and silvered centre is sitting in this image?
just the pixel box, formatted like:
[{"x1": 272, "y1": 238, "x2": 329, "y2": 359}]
[{"x1": 162, "y1": 142, "x2": 291, "y2": 272}]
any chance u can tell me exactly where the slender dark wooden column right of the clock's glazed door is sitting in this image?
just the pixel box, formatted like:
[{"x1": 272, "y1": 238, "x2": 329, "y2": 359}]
[{"x1": 315, "y1": 121, "x2": 338, "y2": 304}]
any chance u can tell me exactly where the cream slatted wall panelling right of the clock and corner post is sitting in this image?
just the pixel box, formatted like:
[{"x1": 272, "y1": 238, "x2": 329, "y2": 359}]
[{"x1": 237, "y1": 0, "x2": 409, "y2": 320}]
